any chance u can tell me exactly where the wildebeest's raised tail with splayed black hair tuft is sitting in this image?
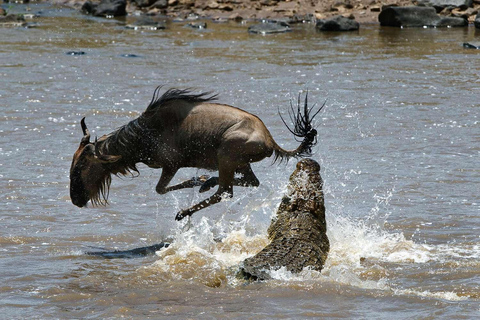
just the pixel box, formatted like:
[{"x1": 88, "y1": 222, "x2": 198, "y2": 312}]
[{"x1": 274, "y1": 91, "x2": 325, "y2": 162}]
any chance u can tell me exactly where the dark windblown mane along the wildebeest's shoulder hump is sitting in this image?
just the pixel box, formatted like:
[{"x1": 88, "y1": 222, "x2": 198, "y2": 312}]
[{"x1": 144, "y1": 86, "x2": 217, "y2": 116}]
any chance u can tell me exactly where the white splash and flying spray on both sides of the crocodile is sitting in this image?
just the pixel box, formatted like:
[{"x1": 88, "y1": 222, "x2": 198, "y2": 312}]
[{"x1": 144, "y1": 156, "x2": 480, "y2": 301}]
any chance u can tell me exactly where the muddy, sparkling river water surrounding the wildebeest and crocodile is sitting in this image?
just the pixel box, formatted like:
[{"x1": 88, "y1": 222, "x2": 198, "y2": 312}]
[{"x1": 0, "y1": 5, "x2": 480, "y2": 319}]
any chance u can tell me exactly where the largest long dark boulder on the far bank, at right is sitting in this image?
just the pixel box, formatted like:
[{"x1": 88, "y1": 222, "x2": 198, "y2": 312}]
[{"x1": 378, "y1": 6, "x2": 468, "y2": 28}]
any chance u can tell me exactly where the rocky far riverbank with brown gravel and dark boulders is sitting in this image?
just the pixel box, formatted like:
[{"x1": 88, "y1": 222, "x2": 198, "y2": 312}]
[{"x1": 0, "y1": 0, "x2": 480, "y2": 29}]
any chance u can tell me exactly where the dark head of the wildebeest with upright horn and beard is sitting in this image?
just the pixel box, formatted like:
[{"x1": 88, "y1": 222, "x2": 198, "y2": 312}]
[{"x1": 70, "y1": 118, "x2": 121, "y2": 207}]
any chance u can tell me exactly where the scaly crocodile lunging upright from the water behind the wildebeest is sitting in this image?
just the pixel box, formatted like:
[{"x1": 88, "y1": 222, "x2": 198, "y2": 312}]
[{"x1": 239, "y1": 159, "x2": 330, "y2": 280}]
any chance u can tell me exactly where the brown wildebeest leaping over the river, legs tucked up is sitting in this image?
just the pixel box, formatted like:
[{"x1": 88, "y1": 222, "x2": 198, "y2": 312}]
[{"x1": 70, "y1": 87, "x2": 323, "y2": 220}]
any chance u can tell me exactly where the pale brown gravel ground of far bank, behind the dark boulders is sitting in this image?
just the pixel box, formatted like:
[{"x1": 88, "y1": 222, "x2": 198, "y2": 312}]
[{"x1": 31, "y1": 0, "x2": 480, "y2": 23}]
